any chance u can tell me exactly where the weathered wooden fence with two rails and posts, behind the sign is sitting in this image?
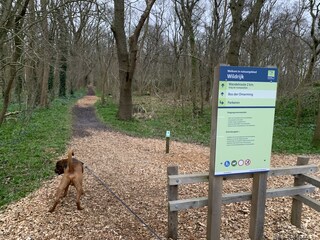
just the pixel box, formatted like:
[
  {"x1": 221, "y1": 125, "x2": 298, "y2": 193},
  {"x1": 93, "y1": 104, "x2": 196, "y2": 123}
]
[{"x1": 168, "y1": 157, "x2": 320, "y2": 239}]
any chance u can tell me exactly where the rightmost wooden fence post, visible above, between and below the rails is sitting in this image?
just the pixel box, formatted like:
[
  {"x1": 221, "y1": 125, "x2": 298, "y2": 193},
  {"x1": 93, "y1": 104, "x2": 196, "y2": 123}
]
[{"x1": 291, "y1": 157, "x2": 309, "y2": 228}]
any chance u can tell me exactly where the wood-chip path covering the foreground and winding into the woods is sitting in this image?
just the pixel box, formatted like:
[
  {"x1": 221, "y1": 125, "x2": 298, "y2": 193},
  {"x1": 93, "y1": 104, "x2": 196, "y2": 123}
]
[{"x1": 0, "y1": 92, "x2": 320, "y2": 240}]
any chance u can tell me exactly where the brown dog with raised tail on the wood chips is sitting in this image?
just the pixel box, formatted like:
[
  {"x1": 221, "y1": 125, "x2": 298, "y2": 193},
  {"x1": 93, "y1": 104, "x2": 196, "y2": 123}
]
[{"x1": 49, "y1": 150, "x2": 84, "y2": 212}]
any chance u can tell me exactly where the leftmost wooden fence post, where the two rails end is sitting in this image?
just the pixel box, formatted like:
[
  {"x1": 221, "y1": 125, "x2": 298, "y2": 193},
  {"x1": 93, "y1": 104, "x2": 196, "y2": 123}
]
[{"x1": 167, "y1": 166, "x2": 178, "y2": 240}]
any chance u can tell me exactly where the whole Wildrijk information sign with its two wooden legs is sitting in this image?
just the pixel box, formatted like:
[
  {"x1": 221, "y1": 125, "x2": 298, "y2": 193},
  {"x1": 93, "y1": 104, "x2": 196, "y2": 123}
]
[{"x1": 207, "y1": 65, "x2": 278, "y2": 240}]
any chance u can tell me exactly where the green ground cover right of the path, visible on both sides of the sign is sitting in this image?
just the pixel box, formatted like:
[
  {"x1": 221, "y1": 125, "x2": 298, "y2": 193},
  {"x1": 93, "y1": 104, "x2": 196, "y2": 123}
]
[{"x1": 96, "y1": 97, "x2": 320, "y2": 154}]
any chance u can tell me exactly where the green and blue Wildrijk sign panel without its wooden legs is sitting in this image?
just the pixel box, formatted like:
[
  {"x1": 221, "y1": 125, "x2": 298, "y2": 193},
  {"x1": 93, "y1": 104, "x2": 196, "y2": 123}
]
[{"x1": 214, "y1": 66, "x2": 278, "y2": 175}]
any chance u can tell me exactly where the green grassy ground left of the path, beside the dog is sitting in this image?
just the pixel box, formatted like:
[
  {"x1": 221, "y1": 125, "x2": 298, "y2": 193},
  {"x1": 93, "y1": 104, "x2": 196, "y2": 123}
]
[{"x1": 0, "y1": 94, "x2": 80, "y2": 208}]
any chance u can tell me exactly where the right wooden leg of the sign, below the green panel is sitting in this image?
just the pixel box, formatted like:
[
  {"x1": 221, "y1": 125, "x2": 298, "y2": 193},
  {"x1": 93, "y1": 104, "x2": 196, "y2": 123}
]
[{"x1": 249, "y1": 172, "x2": 268, "y2": 240}]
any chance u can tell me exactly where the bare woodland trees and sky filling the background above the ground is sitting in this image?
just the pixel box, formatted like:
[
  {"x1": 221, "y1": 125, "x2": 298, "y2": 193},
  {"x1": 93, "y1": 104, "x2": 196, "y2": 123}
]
[{"x1": 0, "y1": 0, "x2": 320, "y2": 146}]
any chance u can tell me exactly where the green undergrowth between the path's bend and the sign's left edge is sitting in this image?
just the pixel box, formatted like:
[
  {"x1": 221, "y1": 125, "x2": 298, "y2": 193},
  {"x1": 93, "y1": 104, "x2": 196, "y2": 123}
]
[{"x1": 96, "y1": 98, "x2": 210, "y2": 145}]
